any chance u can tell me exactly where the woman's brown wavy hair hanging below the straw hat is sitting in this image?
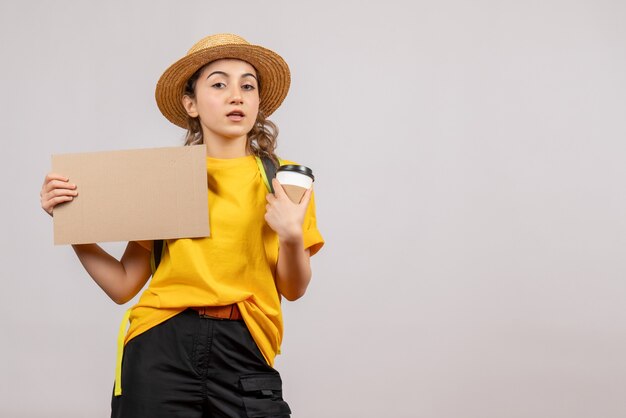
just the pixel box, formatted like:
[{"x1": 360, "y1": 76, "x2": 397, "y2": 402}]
[{"x1": 183, "y1": 63, "x2": 279, "y2": 167}]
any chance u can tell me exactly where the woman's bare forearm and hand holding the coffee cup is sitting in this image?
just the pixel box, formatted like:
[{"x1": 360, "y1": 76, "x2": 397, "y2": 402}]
[{"x1": 265, "y1": 179, "x2": 312, "y2": 301}]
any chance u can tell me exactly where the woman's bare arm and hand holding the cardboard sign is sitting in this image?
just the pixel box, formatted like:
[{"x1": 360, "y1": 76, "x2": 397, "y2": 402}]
[{"x1": 40, "y1": 173, "x2": 152, "y2": 304}]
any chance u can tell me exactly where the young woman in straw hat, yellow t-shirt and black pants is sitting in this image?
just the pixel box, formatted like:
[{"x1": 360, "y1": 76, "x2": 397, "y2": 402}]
[{"x1": 41, "y1": 34, "x2": 324, "y2": 418}]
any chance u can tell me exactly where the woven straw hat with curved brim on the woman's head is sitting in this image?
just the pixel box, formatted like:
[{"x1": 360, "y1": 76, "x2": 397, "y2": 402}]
[{"x1": 155, "y1": 33, "x2": 291, "y2": 129}]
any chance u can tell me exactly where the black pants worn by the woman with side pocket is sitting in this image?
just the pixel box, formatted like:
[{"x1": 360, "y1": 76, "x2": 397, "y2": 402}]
[{"x1": 111, "y1": 309, "x2": 291, "y2": 418}]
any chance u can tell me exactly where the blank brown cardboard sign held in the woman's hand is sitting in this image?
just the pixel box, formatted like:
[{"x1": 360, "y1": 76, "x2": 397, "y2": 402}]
[{"x1": 52, "y1": 145, "x2": 209, "y2": 244}]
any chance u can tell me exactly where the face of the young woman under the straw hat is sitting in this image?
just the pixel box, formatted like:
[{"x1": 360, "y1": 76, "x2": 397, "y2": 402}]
[{"x1": 183, "y1": 59, "x2": 259, "y2": 142}]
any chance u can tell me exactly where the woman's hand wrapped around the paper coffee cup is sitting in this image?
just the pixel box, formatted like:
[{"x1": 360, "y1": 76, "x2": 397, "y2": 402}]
[{"x1": 265, "y1": 179, "x2": 313, "y2": 243}]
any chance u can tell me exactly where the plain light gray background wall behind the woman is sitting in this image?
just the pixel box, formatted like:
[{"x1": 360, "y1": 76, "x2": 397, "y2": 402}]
[{"x1": 0, "y1": 0, "x2": 626, "y2": 418}]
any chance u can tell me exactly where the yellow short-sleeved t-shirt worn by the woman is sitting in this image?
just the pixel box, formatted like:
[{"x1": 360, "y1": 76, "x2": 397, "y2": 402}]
[{"x1": 125, "y1": 156, "x2": 324, "y2": 366}]
